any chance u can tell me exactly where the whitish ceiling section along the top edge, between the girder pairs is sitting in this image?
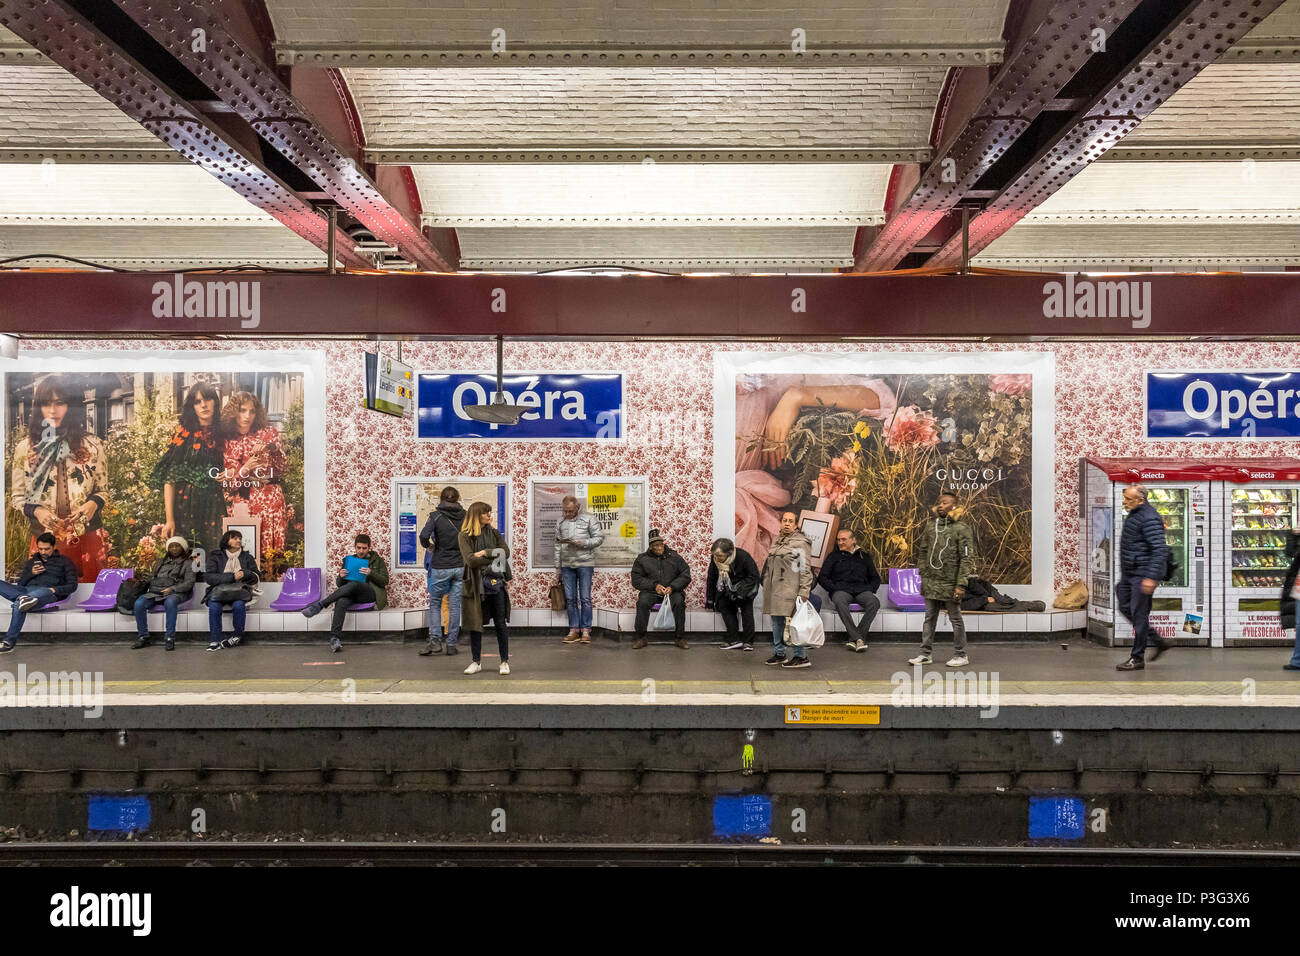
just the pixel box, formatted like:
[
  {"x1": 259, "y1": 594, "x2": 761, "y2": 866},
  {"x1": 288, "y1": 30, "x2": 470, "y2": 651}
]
[{"x1": 267, "y1": 0, "x2": 1008, "y2": 49}]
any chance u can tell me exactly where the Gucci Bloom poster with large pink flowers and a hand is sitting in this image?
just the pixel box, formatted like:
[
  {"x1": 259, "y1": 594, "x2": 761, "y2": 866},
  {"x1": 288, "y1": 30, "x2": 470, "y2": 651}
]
[{"x1": 735, "y1": 372, "x2": 1034, "y2": 585}]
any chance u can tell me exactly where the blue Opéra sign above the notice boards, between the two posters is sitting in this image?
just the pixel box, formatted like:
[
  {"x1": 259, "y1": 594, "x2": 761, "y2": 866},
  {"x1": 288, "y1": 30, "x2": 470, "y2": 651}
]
[{"x1": 415, "y1": 372, "x2": 623, "y2": 441}]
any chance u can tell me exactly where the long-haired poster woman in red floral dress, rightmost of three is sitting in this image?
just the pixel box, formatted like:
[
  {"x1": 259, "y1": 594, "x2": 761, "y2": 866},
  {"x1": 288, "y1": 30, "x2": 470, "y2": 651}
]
[{"x1": 221, "y1": 392, "x2": 290, "y2": 568}]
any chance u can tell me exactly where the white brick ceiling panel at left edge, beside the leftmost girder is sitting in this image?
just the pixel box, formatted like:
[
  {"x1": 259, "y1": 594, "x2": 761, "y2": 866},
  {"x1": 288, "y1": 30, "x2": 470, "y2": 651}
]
[{"x1": 0, "y1": 64, "x2": 165, "y2": 150}]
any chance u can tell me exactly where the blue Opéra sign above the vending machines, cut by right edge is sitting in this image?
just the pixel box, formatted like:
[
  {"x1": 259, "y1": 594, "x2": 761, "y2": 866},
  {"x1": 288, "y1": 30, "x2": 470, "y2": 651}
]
[{"x1": 1145, "y1": 371, "x2": 1300, "y2": 440}]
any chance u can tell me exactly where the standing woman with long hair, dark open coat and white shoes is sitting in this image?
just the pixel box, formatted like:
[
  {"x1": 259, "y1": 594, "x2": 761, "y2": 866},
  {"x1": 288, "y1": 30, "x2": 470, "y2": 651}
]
[{"x1": 456, "y1": 501, "x2": 510, "y2": 674}]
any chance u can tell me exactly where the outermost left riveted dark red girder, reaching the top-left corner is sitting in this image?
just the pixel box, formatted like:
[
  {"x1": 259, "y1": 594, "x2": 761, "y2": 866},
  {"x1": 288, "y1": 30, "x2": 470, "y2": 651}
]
[{"x1": 0, "y1": 0, "x2": 373, "y2": 269}]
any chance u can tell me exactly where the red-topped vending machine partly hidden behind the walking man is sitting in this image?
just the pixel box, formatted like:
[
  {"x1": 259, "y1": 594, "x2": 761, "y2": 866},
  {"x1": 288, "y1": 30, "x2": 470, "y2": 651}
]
[{"x1": 1080, "y1": 458, "x2": 1216, "y2": 646}]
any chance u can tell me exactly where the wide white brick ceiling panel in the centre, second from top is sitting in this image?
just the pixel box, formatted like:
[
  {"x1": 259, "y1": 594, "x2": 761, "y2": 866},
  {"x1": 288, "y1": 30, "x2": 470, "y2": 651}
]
[{"x1": 346, "y1": 68, "x2": 945, "y2": 148}]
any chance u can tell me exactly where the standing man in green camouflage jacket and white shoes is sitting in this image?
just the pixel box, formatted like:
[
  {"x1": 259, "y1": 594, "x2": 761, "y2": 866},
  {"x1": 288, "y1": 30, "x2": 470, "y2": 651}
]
[{"x1": 907, "y1": 493, "x2": 975, "y2": 667}]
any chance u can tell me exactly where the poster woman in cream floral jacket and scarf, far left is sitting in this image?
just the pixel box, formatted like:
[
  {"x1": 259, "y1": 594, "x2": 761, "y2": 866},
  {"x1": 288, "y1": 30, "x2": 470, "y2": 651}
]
[{"x1": 9, "y1": 375, "x2": 108, "y2": 581}]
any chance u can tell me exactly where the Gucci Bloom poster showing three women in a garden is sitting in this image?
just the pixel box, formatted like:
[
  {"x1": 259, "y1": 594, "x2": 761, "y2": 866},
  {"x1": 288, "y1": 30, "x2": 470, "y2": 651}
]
[{"x1": 4, "y1": 354, "x2": 321, "y2": 583}]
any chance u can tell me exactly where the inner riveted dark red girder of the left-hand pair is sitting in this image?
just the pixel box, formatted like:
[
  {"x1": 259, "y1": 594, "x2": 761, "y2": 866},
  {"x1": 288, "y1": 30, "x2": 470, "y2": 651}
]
[{"x1": 117, "y1": 0, "x2": 455, "y2": 272}]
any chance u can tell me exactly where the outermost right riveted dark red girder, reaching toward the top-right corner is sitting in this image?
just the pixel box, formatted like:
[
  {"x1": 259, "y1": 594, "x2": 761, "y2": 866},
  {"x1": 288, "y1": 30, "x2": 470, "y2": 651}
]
[{"x1": 926, "y1": 0, "x2": 1282, "y2": 267}]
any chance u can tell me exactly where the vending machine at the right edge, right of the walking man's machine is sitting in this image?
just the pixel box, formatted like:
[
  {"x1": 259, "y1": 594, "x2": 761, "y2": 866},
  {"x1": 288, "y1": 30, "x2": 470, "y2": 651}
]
[{"x1": 1214, "y1": 459, "x2": 1300, "y2": 646}]
